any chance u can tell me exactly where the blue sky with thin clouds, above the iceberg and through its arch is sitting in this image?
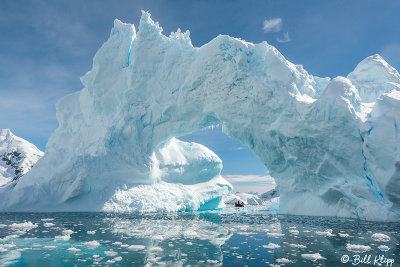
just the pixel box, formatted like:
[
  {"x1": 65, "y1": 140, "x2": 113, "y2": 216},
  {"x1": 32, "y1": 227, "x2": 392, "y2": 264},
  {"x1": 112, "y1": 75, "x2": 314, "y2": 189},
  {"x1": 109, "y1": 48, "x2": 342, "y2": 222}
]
[{"x1": 0, "y1": 0, "x2": 400, "y2": 193}]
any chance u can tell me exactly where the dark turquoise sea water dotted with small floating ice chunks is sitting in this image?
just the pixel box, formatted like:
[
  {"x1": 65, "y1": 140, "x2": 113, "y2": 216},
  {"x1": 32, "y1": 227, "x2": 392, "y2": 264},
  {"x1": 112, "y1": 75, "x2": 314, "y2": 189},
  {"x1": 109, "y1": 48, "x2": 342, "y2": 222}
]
[{"x1": 0, "y1": 208, "x2": 400, "y2": 266}]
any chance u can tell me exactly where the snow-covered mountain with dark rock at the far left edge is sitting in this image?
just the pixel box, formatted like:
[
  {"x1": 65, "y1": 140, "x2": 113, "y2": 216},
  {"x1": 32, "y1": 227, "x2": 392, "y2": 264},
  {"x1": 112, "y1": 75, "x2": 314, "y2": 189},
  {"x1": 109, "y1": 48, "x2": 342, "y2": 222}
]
[{"x1": 0, "y1": 129, "x2": 44, "y2": 186}]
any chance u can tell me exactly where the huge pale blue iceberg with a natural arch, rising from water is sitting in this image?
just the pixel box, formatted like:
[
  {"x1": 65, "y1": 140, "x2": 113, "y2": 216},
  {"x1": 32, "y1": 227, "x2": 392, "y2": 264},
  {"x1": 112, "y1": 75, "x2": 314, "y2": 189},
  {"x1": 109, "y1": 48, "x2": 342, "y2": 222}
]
[{"x1": 0, "y1": 13, "x2": 400, "y2": 220}]
